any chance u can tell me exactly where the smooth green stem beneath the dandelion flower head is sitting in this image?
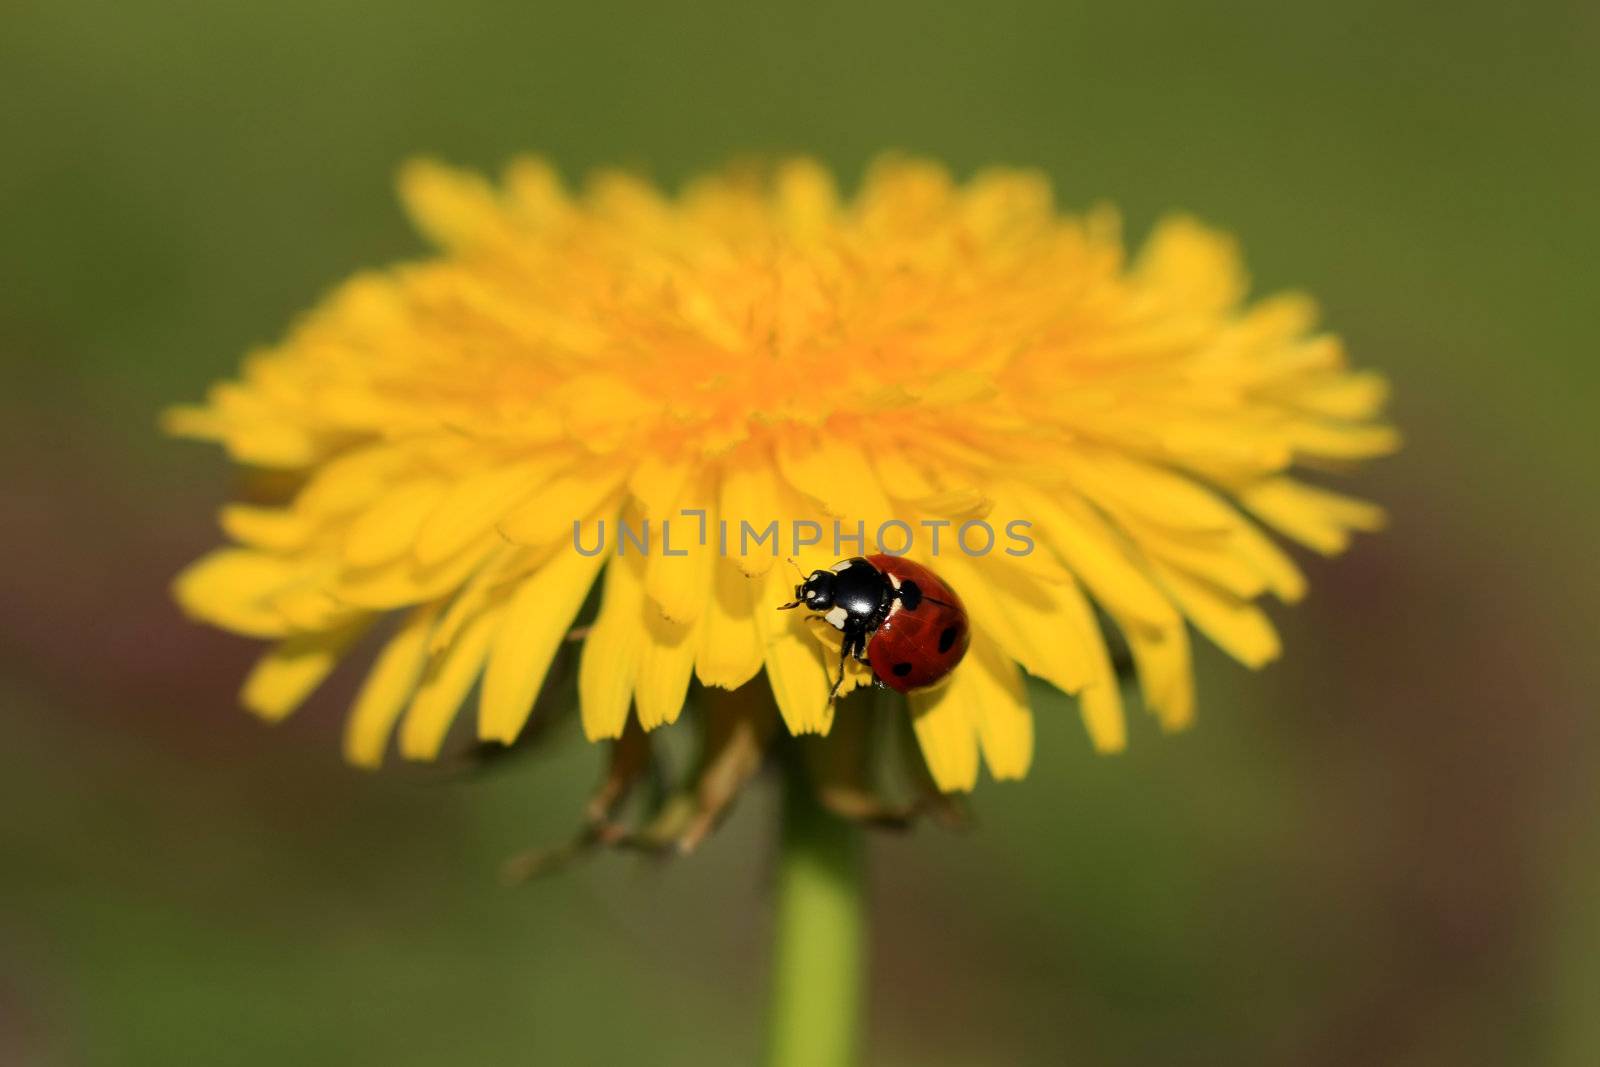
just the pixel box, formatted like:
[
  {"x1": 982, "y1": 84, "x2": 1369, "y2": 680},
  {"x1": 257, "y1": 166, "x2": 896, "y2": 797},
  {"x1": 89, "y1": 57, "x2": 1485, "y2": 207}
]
[{"x1": 766, "y1": 760, "x2": 866, "y2": 1067}]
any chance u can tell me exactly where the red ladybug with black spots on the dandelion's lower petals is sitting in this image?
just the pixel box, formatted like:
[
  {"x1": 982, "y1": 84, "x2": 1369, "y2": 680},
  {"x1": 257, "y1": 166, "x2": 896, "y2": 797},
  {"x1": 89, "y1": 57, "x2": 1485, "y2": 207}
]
[{"x1": 779, "y1": 555, "x2": 971, "y2": 699}]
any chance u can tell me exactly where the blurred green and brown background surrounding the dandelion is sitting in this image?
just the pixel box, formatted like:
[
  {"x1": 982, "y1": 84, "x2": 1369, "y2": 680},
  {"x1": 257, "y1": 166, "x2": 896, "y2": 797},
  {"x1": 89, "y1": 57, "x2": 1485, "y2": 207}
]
[{"x1": 0, "y1": 0, "x2": 1600, "y2": 1065}]
